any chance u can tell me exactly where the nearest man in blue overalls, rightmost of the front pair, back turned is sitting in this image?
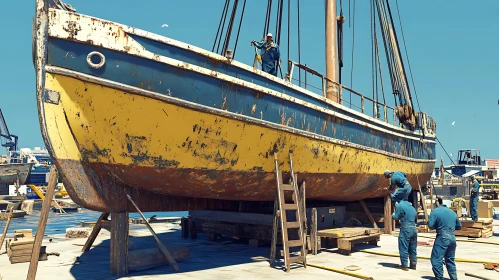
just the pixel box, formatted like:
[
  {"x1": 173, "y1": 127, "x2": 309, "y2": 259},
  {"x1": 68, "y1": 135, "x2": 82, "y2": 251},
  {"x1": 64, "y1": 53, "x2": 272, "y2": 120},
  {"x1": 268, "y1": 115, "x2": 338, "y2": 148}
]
[{"x1": 428, "y1": 197, "x2": 461, "y2": 280}]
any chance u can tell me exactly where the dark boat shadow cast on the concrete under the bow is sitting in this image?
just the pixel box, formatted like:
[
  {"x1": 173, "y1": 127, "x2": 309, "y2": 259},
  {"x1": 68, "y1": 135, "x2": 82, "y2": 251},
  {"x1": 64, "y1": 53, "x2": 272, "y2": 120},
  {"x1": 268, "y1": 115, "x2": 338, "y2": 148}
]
[{"x1": 70, "y1": 229, "x2": 270, "y2": 279}]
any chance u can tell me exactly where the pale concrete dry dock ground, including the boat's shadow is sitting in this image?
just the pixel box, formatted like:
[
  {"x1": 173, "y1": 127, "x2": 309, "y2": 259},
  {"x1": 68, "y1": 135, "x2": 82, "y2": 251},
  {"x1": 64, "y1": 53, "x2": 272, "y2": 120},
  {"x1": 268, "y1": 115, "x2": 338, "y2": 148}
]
[{"x1": 0, "y1": 221, "x2": 499, "y2": 280}]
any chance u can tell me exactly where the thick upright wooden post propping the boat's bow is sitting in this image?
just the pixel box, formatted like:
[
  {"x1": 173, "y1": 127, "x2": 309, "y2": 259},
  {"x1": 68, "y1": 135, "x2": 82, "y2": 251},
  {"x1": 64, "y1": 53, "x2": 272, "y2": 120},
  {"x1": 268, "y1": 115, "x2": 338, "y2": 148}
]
[{"x1": 111, "y1": 212, "x2": 128, "y2": 277}]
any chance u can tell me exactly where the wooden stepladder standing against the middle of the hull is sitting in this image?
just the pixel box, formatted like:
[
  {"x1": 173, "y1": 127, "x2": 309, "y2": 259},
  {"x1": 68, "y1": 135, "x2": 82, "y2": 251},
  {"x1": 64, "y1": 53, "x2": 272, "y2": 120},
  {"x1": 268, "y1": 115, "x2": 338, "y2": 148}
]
[{"x1": 271, "y1": 154, "x2": 307, "y2": 272}]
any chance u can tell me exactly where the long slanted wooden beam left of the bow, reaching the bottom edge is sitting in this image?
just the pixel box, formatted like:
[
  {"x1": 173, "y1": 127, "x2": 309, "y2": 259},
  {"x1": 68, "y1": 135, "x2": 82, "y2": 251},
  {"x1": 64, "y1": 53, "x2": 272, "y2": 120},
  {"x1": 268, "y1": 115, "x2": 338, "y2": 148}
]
[{"x1": 26, "y1": 165, "x2": 59, "y2": 280}]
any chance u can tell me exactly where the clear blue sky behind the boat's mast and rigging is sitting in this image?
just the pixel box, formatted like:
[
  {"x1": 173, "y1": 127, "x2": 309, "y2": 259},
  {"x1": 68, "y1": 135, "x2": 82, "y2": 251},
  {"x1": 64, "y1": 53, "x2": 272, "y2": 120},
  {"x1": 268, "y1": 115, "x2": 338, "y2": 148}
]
[{"x1": 0, "y1": 0, "x2": 499, "y2": 164}]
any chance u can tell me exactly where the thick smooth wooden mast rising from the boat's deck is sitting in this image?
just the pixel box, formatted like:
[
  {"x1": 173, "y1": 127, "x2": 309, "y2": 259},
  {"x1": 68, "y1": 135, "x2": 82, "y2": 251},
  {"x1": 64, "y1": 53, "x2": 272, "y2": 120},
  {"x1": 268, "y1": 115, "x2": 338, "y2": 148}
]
[{"x1": 326, "y1": 0, "x2": 339, "y2": 102}]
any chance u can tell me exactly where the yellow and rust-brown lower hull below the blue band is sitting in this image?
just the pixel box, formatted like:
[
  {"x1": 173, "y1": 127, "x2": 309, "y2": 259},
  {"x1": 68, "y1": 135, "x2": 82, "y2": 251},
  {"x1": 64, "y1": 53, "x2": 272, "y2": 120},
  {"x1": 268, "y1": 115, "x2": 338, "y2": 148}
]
[{"x1": 43, "y1": 73, "x2": 434, "y2": 211}]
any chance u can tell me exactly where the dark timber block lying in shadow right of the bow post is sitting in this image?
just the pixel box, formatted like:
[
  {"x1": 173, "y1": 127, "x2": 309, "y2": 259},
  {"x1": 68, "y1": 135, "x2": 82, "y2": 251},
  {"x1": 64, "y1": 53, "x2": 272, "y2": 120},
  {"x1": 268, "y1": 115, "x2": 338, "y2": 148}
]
[{"x1": 128, "y1": 246, "x2": 189, "y2": 268}]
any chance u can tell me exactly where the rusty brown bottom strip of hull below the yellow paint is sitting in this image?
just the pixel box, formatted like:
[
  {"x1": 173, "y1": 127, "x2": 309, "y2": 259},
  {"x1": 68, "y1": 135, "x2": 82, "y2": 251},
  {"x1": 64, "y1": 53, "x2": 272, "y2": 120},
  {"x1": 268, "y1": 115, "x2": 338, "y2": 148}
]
[{"x1": 56, "y1": 160, "x2": 429, "y2": 211}]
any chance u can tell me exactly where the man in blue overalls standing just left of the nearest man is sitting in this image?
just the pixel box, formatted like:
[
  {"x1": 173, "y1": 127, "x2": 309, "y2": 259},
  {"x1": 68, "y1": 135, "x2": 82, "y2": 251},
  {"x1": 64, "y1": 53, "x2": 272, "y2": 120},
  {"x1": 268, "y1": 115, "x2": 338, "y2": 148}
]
[{"x1": 392, "y1": 200, "x2": 418, "y2": 271}]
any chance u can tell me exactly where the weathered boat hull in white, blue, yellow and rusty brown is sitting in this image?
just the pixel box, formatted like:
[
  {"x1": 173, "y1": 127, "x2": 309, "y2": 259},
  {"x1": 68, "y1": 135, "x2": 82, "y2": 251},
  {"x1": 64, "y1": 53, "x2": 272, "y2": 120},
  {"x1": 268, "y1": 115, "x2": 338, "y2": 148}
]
[{"x1": 33, "y1": 3, "x2": 435, "y2": 212}]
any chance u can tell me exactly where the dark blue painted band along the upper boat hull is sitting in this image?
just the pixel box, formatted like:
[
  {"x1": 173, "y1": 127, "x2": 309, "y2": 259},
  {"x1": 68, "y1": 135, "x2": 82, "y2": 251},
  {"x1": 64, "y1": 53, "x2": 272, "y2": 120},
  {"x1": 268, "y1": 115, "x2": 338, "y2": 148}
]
[{"x1": 47, "y1": 38, "x2": 435, "y2": 159}]
